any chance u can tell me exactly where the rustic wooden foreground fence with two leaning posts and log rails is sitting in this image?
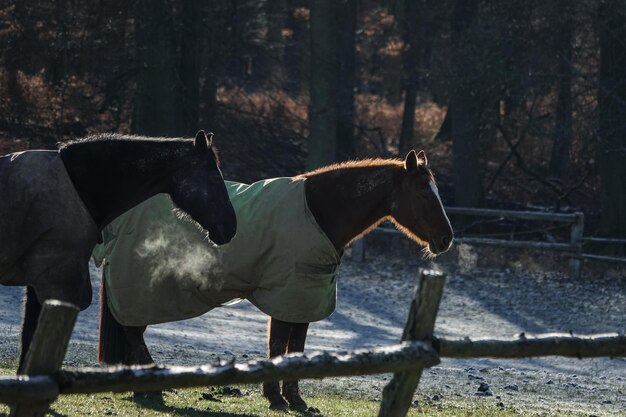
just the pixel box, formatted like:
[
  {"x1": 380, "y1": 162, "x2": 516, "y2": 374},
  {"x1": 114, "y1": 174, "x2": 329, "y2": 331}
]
[{"x1": 0, "y1": 271, "x2": 626, "y2": 417}]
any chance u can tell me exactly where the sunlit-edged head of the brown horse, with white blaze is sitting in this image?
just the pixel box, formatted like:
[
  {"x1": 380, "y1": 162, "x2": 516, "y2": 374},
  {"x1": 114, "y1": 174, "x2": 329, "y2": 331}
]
[{"x1": 391, "y1": 150, "x2": 453, "y2": 255}]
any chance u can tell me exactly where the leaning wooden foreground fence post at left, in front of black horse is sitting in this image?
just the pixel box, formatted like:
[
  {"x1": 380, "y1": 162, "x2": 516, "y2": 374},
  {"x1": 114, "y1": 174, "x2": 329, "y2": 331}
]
[{"x1": 10, "y1": 300, "x2": 79, "y2": 417}]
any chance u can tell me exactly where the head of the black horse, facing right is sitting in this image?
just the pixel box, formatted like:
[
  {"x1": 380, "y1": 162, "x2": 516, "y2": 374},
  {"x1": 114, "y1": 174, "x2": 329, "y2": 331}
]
[{"x1": 169, "y1": 130, "x2": 237, "y2": 245}]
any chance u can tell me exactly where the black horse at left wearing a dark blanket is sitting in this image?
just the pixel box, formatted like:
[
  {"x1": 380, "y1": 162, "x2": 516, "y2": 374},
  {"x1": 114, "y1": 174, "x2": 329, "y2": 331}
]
[{"x1": 0, "y1": 131, "x2": 237, "y2": 373}]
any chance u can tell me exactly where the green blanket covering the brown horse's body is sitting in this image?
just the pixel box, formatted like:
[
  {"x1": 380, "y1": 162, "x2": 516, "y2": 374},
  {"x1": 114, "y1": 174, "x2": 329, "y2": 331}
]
[{"x1": 94, "y1": 178, "x2": 340, "y2": 326}]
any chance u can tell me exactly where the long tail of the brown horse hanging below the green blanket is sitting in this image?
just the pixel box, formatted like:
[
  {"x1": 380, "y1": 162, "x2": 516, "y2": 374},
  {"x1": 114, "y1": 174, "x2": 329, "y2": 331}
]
[{"x1": 98, "y1": 267, "x2": 126, "y2": 365}]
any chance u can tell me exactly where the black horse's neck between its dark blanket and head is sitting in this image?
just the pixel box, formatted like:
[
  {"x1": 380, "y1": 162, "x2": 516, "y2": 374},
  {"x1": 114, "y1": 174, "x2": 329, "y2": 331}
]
[{"x1": 61, "y1": 139, "x2": 191, "y2": 228}]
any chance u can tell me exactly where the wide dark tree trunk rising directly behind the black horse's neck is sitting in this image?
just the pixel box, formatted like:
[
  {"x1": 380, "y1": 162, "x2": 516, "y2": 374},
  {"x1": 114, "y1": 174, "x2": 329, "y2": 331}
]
[{"x1": 132, "y1": 0, "x2": 184, "y2": 136}]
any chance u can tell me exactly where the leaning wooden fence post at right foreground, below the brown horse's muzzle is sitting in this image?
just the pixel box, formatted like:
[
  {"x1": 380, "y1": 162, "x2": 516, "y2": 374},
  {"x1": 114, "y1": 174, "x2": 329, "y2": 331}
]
[{"x1": 378, "y1": 270, "x2": 446, "y2": 417}]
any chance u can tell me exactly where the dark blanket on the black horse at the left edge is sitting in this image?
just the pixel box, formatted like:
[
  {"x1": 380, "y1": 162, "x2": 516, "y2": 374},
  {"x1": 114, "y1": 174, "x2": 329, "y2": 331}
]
[{"x1": 0, "y1": 151, "x2": 100, "y2": 309}]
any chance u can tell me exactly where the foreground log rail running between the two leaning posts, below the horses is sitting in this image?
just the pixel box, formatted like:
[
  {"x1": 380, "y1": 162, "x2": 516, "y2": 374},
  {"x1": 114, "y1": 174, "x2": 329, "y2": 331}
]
[{"x1": 57, "y1": 342, "x2": 439, "y2": 394}]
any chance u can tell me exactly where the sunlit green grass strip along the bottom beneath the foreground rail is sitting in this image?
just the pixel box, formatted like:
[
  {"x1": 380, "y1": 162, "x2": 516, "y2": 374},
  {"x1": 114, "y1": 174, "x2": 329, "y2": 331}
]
[{"x1": 0, "y1": 363, "x2": 604, "y2": 417}]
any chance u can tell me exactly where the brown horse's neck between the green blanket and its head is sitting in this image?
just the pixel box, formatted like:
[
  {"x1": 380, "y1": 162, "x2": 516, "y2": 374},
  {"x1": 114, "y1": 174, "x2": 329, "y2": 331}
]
[{"x1": 304, "y1": 163, "x2": 401, "y2": 251}]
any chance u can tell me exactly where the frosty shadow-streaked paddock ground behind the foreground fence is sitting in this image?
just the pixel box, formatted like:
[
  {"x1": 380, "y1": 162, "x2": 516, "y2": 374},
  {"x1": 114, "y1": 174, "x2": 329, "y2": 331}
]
[{"x1": 0, "y1": 239, "x2": 626, "y2": 416}]
